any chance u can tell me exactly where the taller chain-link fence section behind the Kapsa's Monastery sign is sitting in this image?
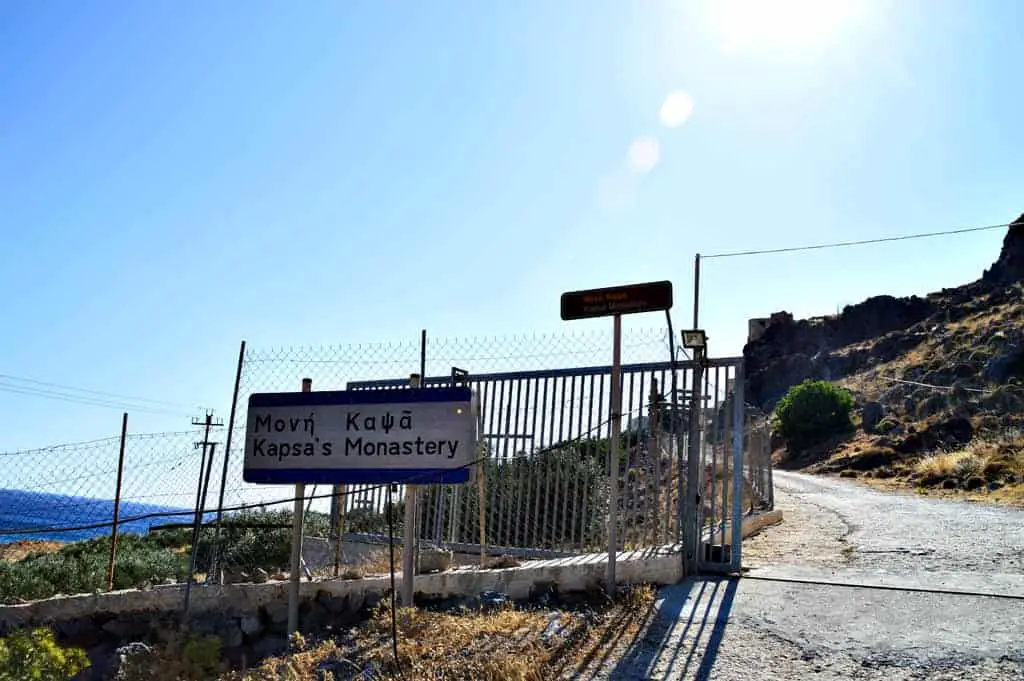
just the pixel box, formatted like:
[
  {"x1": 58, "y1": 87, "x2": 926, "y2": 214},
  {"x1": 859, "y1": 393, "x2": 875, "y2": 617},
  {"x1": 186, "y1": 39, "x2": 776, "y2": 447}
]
[{"x1": 227, "y1": 330, "x2": 704, "y2": 552}]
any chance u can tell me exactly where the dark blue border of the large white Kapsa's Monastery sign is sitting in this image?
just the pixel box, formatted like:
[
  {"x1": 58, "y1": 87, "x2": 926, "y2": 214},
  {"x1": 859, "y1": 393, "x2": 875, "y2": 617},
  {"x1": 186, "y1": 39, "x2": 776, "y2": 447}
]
[{"x1": 242, "y1": 386, "x2": 479, "y2": 484}]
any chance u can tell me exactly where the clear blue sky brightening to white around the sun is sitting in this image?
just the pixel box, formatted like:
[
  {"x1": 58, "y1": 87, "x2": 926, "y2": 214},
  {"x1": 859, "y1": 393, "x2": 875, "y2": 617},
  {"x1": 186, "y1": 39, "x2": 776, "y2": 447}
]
[{"x1": 0, "y1": 0, "x2": 1024, "y2": 450}]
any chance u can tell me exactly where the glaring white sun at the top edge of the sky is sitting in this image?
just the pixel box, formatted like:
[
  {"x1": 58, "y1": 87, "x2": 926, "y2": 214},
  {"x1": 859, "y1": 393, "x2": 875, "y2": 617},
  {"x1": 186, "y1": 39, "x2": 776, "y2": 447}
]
[{"x1": 712, "y1": 0, "x2": 864, "y2": 52}]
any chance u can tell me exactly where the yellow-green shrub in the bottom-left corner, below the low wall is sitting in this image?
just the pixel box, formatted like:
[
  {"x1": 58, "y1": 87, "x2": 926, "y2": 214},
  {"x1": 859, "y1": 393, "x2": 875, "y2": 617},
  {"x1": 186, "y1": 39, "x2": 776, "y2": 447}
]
[{"x1": 0, "y1": 629, "x2": 89, "y2": 681}]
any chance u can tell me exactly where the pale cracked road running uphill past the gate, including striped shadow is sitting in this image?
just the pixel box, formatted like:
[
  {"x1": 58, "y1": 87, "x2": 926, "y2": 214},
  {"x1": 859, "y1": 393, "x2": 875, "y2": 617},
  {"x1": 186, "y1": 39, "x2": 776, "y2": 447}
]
[{"x1": 573, "y1": 472, "x2": 1024, "y2": 681}]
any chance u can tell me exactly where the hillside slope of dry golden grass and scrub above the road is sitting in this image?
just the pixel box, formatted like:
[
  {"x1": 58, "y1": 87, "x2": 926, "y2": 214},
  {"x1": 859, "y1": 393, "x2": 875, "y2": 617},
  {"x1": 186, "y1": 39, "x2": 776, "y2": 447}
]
[{"x1": 774, "y1": 285, "x2": 1024, "y2": 505}]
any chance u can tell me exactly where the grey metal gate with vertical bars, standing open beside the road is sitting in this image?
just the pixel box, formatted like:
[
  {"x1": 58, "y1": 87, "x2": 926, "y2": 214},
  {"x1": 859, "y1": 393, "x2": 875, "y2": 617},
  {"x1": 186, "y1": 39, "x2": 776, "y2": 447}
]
[{"x1": 335, "y1": 358, "x2": 770, "y2": 570}]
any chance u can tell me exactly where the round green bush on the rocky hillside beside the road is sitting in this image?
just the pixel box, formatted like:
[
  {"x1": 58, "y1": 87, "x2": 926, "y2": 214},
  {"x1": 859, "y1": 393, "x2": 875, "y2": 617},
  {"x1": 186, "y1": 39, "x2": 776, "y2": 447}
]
[{"x1": 772, "y1": 380, "x2": 854, "y2": 451}]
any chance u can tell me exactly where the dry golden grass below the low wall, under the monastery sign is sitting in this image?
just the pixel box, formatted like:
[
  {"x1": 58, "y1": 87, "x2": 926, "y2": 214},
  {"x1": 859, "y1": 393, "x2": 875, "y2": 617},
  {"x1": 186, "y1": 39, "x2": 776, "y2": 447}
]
[{"x1": 112, "y1": 586, "x2": 654, "y2": 681}]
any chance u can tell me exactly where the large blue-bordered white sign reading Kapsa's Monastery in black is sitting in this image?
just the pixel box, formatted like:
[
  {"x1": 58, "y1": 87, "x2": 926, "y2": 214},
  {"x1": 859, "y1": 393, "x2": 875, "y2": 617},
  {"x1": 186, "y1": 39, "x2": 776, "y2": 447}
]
[{"x1": 242, "y1": 387, "x2": 479, "y2": 484}]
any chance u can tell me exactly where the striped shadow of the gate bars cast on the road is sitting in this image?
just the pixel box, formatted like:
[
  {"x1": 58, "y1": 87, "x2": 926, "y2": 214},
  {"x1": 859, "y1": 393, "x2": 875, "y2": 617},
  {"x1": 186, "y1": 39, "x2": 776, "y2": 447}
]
[{"x1": 573, "y1": 577, "x2": 738, "y2": 681}]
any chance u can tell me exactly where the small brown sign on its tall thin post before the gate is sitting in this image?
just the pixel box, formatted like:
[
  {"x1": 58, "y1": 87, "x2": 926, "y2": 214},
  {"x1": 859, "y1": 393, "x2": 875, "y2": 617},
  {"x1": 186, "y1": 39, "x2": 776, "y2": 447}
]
[{"x1": 561, "y1": 282, "x2": 672, "y2": 598}]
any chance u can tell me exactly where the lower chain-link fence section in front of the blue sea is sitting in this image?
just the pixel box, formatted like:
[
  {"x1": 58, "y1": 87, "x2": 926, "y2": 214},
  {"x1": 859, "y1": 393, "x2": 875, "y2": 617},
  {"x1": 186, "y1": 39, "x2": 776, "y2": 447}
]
[{"x1": 0, "y1": 431, "x2": 202, "y2": 544}]
